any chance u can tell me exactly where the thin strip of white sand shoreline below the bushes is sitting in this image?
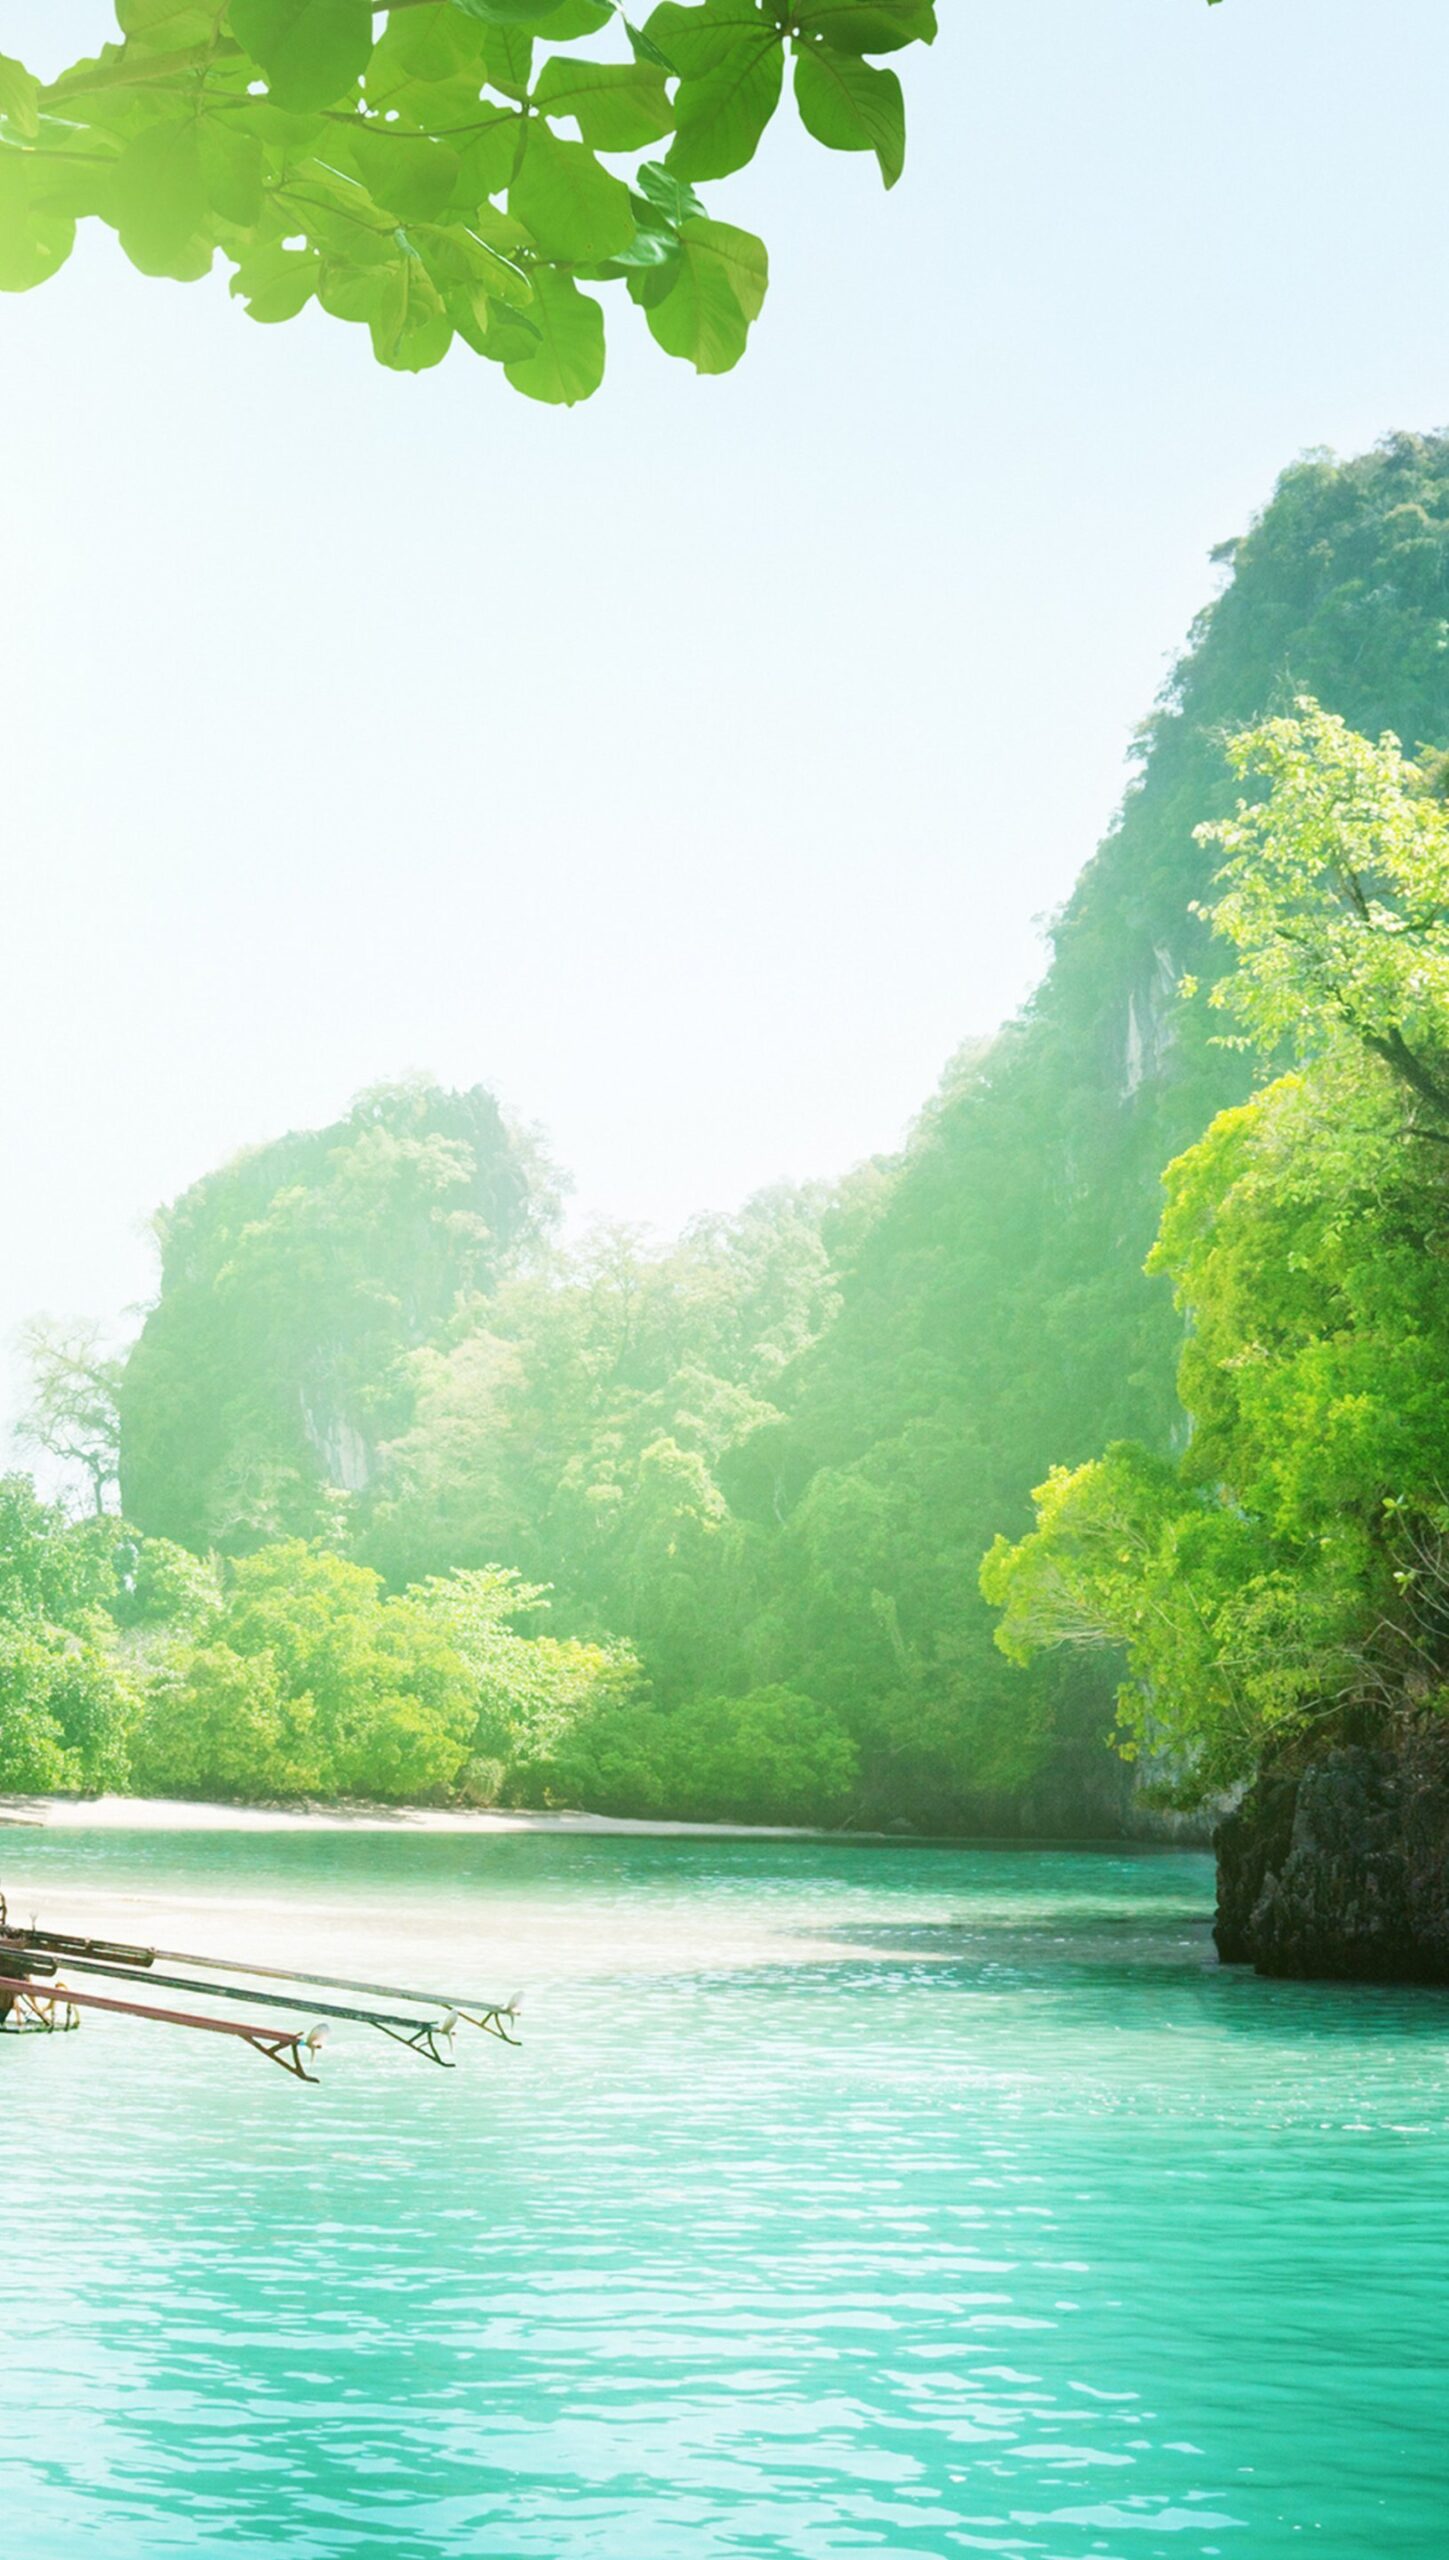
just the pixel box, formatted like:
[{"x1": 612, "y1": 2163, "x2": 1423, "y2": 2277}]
[{"x1": 0, "y1": 1795, "x2": 844, "y2": 1841}]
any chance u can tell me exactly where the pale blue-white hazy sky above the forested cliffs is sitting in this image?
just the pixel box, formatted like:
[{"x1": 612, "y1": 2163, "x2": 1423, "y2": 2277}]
[{"x1": 0, "y1": 0, "x2": 1449, "y2": 1423}]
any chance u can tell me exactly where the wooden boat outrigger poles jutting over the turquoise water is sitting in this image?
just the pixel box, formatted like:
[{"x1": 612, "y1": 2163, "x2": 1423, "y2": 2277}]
[{"x1": 0, "y1": 1894, "x2": 520, "y2": 2081}]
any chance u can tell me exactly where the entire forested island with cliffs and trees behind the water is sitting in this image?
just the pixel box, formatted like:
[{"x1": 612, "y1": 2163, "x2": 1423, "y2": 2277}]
[{"x1": 0, "y1": 435, "x2": 1449, "y2": 1974}]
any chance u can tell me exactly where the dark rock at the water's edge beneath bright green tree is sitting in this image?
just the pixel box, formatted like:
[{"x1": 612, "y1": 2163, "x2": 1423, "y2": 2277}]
[{"x1": 1213, "y1": 1728, "x2": 1449, "y2": 1981}]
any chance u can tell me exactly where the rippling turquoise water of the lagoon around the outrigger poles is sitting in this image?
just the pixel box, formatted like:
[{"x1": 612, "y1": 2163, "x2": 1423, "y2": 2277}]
[{"x1": 0, "y1": 1833, "x2": 1449, "y2": 2560}]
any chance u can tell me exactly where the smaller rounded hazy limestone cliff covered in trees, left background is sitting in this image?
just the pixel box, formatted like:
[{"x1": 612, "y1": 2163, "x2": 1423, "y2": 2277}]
[{"x1": 120, "y1": 1083, "x2": 538, "y2": 1551}]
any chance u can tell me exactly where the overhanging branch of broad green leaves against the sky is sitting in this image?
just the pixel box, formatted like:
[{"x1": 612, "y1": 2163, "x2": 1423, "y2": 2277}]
[{"x1": 0, "y1": 0, "x2": 934, "y2": 404}]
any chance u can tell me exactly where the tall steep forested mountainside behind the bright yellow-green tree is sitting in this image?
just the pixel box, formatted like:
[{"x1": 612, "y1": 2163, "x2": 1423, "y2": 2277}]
[{"x1": 732, "y1": 438, "x2": 1449, "y2": 1828}]
